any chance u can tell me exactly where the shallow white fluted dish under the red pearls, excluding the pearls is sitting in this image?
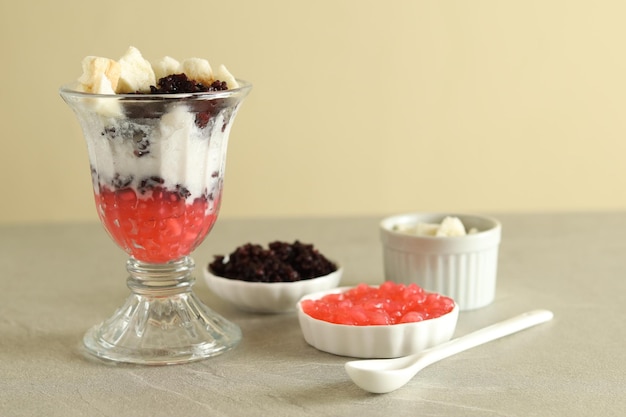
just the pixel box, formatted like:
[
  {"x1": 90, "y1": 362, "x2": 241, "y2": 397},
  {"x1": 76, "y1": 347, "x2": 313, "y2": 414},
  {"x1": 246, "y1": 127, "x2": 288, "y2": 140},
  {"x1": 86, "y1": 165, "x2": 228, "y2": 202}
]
[{"x1": 298, "y1": 287, "x2": 459, "y2": 358}]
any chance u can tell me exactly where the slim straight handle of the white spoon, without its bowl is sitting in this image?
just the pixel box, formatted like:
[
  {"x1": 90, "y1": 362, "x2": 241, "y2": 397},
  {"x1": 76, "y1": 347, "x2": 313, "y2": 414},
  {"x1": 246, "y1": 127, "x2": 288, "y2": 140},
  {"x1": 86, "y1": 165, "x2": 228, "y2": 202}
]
[{"x1": 418, "y1": 310, "x2": 554, "y2": 369}]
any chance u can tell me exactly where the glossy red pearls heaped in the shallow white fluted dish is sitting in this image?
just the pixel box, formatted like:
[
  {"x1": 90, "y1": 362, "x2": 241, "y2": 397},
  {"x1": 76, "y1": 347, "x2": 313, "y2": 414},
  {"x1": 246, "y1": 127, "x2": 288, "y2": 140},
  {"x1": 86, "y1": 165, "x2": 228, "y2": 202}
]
[{"x1": 301, "y1": 281, "x2": 454, "y2": 326}]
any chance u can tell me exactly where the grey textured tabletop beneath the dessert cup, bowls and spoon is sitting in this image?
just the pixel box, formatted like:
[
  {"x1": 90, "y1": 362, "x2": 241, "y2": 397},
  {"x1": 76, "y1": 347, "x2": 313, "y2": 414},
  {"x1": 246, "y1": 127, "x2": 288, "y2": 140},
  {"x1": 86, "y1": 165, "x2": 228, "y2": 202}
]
[{"x1": 0, "y1": 213, "x2": 626, "y2": 417}]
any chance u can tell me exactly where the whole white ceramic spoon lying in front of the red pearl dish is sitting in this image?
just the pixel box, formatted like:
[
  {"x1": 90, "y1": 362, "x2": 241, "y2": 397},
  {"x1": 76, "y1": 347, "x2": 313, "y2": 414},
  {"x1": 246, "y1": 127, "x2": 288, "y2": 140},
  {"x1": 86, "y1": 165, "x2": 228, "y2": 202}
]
[{"x1": 345, "y1": 310, "x2": 554, "y2": 394}]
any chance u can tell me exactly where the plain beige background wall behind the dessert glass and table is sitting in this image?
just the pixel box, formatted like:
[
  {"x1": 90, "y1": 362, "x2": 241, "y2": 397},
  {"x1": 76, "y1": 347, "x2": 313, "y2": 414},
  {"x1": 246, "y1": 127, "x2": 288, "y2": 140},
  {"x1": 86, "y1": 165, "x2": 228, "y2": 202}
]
[{"x1": 0, "y1": 0, "x2": 626, "y2": 223}]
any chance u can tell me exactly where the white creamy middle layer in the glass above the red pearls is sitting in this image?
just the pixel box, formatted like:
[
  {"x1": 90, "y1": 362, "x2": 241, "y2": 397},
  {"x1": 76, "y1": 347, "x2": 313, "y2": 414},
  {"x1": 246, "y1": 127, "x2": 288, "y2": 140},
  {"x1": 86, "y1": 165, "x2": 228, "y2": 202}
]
[{"x1": 87, "y1": 105, "x2": 230, "y2": 201}]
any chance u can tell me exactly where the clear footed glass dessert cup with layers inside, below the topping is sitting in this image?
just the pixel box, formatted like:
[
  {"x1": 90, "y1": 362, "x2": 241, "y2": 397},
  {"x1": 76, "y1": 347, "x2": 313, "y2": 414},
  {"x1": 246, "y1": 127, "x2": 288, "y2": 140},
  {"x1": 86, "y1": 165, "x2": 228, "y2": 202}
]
[{"x1": 60, "y1": 81, "x2": 251, "y2": 365}]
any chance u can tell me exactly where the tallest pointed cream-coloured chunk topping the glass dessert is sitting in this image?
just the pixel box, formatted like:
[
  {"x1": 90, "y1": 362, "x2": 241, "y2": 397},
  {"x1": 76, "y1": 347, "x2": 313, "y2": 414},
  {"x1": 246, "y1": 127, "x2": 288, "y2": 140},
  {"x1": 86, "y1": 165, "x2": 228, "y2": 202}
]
[{"x1": 115, "y1": 46, "x2": 156, "y2": 94}]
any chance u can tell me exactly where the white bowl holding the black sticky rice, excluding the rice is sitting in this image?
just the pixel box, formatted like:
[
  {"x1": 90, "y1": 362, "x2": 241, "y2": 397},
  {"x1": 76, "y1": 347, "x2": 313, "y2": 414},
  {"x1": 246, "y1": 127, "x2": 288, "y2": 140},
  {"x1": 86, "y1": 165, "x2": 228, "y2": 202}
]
[{"x1": 204, "y1": 263, "x2": 343, "y2": 313}]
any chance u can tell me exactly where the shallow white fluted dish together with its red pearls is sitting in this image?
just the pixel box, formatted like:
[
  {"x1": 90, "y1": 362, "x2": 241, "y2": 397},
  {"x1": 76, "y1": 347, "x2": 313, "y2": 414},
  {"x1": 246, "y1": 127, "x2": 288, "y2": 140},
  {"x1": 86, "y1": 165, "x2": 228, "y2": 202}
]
[{"x1": 298, "y1": 282, "x2": 459, "y2": 358}]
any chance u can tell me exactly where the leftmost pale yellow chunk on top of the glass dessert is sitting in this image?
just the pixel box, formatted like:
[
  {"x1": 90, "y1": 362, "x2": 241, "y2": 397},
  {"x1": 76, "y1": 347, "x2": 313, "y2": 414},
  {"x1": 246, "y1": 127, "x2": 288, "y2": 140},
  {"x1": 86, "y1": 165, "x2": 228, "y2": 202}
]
[{"x1": 78, "y1": 56, "x2": 121, "y2": 94}]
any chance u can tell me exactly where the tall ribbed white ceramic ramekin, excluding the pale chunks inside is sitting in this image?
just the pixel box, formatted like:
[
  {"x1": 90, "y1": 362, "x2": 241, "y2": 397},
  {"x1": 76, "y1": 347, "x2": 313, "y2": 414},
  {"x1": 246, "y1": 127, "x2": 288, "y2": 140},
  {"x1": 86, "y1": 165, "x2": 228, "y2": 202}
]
[{"x1": 380, "y1": 213, "x2": 502, "y2": 310}]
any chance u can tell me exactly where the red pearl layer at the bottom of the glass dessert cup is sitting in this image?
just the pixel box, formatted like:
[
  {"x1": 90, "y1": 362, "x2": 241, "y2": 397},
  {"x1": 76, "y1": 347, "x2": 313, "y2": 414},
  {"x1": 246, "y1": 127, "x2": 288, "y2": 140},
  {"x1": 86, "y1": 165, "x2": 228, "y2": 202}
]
[{"x1": 95, "y1": 186, "x2": 219, "y2": 263}]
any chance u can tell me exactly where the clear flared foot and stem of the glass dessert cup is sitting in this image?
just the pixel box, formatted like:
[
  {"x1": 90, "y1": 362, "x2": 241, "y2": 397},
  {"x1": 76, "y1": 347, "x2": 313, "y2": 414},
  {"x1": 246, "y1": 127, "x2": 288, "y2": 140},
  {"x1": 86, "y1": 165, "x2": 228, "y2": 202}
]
[{"x1": 83, "y1": 258, "x2": 241, "y2": 365}]
